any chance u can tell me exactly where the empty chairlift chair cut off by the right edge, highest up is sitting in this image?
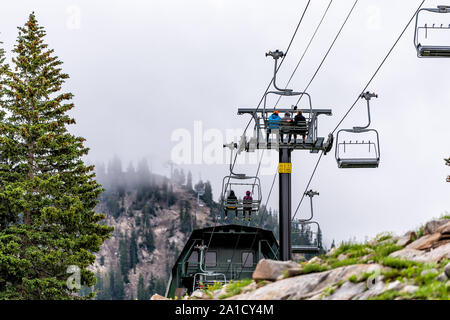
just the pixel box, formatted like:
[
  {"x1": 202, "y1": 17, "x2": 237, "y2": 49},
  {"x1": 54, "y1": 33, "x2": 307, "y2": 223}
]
[{"x1": 414, "y1": 6, "x2": 450, "y2": 58}]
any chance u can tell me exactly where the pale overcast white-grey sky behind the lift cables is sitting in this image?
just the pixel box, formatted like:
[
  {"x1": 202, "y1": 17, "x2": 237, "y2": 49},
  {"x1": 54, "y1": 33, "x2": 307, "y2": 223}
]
[{"x1": 0, "y1": 0, "x2": 450, "y2": 243}]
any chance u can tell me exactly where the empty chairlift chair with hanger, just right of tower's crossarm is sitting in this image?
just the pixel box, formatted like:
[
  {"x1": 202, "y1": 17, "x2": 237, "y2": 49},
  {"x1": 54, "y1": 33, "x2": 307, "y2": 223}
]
[{"x1": 335, "y1": 92, "x2": 380, "y2": 169}]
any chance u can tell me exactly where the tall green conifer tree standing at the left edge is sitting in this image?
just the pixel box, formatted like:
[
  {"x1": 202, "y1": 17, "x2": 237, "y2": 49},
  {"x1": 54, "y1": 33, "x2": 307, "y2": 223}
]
[{"x1": 0, "y1": 13, "x2": 112, "y2": 299}]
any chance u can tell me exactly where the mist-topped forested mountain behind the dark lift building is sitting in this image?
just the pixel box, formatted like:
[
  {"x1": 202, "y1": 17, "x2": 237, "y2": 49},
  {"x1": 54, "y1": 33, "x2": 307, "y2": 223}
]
[{"x1": 85, "y1": 157, "x2": 278, "y2": 300}]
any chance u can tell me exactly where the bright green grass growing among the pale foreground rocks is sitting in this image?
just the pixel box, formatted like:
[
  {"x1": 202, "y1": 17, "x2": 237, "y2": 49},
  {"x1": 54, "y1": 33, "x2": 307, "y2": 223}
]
[{"x1": 255, "y1": 225, "x2": 450, "y2": 300}]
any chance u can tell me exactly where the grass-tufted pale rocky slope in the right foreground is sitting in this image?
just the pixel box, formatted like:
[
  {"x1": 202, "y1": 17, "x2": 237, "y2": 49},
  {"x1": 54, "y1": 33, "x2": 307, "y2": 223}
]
[{"x1": 170, "y1": 217, "x2": 450, "y2": 300}]
